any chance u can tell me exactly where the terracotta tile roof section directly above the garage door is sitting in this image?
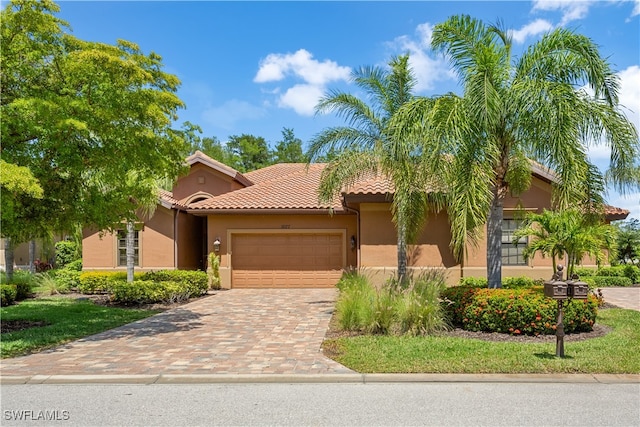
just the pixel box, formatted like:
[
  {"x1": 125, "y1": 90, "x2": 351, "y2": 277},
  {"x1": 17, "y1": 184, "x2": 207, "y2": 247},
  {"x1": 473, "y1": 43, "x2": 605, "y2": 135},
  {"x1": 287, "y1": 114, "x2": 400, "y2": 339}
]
[{"x1": 189, "y1": 163, "x2": 343, "y2": 211}]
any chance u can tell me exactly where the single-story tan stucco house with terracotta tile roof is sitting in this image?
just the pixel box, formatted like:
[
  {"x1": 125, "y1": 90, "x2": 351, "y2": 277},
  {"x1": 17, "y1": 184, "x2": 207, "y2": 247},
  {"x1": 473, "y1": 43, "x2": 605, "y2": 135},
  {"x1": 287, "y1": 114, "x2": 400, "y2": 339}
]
[{"x1": 83, "y1": 152, "x2": 629, "y2": 288}]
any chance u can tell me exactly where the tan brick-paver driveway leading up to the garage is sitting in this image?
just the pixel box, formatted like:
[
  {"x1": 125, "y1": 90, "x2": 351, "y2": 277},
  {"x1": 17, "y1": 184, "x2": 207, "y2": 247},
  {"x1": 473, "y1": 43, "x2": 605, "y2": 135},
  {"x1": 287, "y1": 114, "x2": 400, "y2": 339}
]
[{"x1": 0, "y1": 289, "x2": 352, "y2": 376}]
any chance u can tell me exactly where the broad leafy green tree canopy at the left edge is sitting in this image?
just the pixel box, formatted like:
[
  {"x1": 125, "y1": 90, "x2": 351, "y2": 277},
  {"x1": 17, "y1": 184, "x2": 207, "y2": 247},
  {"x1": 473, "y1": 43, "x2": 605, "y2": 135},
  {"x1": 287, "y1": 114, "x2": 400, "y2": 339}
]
[{"x1": 0, "y1": 0, "x2": 188, "y2": 243}]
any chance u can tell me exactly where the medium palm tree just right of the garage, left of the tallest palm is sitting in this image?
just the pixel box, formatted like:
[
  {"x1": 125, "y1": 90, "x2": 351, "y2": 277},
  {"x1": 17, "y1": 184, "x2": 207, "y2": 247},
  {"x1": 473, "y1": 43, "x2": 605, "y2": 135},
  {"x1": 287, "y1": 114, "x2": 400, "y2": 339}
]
[{"x1": 308, "y1": 55, "x2": 442, "y2": 283}]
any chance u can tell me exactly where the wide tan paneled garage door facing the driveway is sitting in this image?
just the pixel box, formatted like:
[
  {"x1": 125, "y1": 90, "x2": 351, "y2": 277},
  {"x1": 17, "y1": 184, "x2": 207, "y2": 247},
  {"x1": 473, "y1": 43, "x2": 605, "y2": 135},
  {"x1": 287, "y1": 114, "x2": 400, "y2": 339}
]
[{"x1": 231, "y1": 233, "x2": 344, "y2": 288}]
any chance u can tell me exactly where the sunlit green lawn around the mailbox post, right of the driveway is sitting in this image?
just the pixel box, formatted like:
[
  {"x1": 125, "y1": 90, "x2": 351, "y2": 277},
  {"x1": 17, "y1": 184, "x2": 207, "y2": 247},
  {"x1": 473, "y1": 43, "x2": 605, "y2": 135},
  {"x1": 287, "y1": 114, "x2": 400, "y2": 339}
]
[{"x1": 324, "y1": 309, "x2": 640, "y2": 374}]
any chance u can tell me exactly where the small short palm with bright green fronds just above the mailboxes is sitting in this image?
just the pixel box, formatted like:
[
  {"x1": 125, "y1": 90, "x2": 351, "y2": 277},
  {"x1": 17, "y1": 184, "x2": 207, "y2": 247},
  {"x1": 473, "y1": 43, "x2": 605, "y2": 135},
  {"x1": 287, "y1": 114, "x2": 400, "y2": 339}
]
[{"x1": 514, "y1": 209, "x2": 616, "y2": 278}]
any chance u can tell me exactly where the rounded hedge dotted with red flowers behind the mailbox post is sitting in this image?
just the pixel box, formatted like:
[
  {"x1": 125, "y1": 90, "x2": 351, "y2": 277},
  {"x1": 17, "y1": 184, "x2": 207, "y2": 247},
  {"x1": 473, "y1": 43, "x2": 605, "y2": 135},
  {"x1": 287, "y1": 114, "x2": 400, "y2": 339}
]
[{"x1": 442, "y1": 286, "x2": 598, "y2": 335}]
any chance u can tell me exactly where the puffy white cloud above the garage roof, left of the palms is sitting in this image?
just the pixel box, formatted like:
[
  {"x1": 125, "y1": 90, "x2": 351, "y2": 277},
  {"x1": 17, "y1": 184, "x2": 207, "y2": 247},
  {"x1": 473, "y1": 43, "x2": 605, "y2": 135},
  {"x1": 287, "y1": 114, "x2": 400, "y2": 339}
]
[{"x1": 253, "y1": 49, "x2": 351, "y2": 116}]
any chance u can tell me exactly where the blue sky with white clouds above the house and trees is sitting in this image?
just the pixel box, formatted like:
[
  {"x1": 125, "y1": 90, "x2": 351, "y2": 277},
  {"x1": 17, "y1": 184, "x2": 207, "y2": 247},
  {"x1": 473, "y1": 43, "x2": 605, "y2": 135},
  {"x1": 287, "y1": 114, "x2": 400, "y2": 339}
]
[{"x1": 52, "y1": 0, "x2": 640, "y2": 219}]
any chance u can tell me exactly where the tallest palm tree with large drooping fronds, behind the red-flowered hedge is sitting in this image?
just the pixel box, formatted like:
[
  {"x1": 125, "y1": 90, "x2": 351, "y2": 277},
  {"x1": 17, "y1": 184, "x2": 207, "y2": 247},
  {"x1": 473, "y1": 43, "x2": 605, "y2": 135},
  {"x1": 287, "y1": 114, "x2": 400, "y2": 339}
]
[{"x1": 396, "y1": 16, "x2": 640, "y2": 287}]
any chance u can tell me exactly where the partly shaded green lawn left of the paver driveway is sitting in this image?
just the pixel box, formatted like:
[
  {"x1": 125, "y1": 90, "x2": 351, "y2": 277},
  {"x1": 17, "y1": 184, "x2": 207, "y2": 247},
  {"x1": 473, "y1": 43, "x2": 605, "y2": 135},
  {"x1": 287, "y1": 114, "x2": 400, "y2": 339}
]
[{"x1": 0, "y1": 297, "x2": 158, "y2": 359}]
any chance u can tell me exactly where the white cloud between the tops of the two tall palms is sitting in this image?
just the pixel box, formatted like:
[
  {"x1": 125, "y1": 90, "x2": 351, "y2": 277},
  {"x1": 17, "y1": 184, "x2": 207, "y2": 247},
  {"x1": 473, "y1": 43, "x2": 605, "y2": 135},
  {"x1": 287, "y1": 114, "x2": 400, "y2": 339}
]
[{"x1": 389, "y1": 22, "x2": 456, "y2": 92}]
